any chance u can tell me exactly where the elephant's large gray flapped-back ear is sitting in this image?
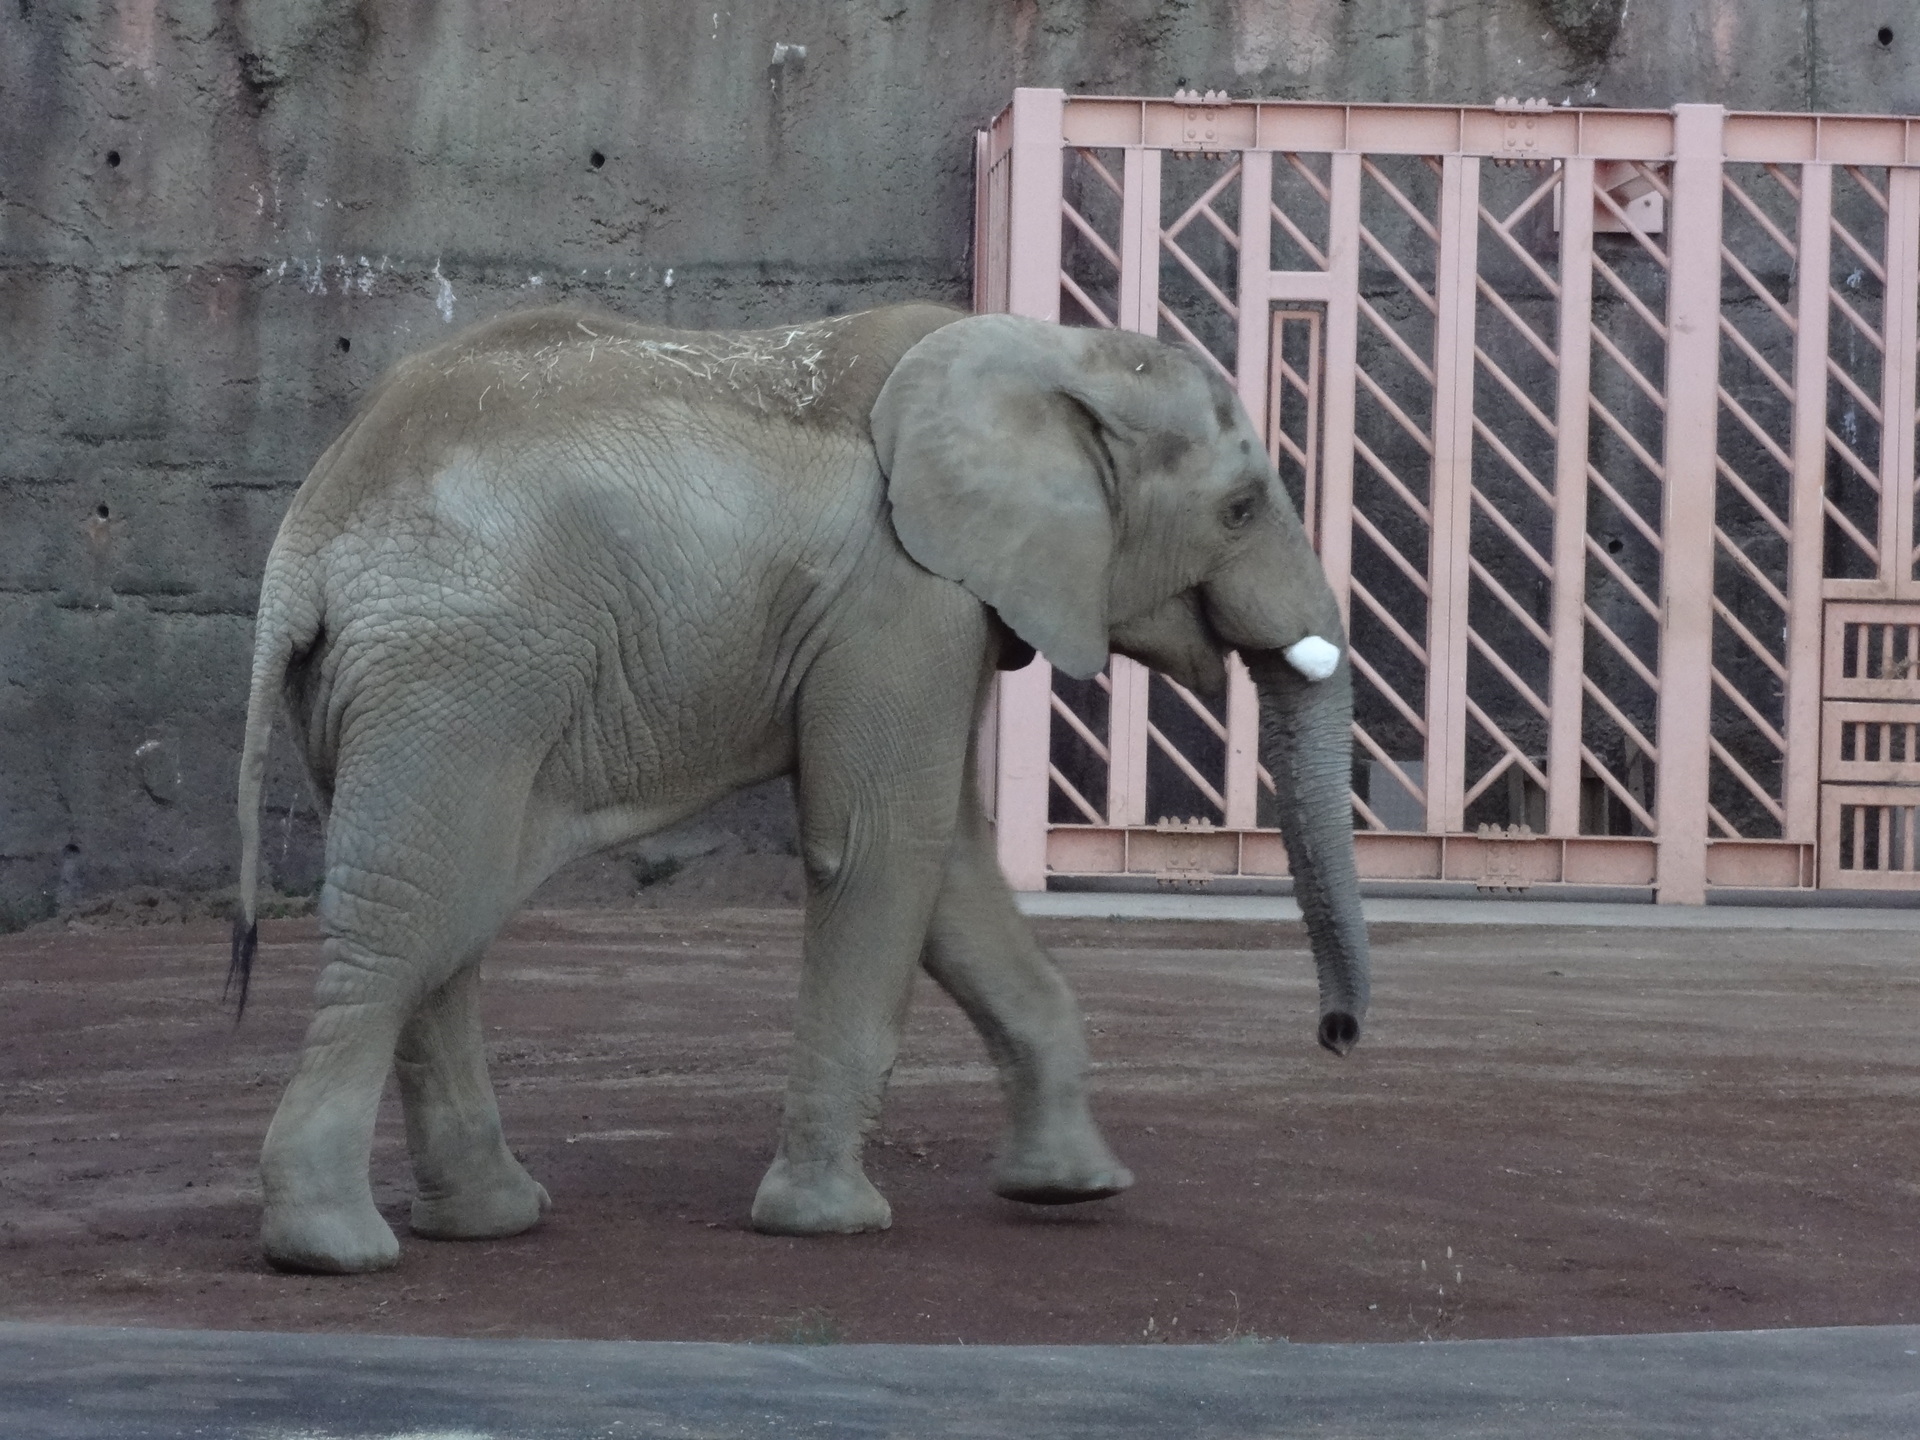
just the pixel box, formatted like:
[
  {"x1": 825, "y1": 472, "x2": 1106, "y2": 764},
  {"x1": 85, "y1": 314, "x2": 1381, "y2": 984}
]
[{"x1": 874, "y1": 315, "x2": 1117, "y2": 680}]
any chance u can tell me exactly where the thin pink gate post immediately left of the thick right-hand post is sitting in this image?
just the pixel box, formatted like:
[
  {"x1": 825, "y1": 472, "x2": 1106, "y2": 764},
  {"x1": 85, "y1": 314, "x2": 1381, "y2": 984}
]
[{"x1": 1548, "y1": 156, "x2": 1594, "y2": 835}]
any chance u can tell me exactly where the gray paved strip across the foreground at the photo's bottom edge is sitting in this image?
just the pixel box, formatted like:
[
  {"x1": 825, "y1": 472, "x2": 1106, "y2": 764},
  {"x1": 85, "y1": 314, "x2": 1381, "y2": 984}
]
[{"x1": 0, "y1": 1325, "x2": 1920, "y2": 1440}]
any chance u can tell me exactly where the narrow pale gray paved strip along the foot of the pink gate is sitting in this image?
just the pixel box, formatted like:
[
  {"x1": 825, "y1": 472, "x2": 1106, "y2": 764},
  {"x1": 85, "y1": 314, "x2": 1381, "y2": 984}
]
[{"x1": 1016, "y1": 891, "x2": 1920, "y2": 935}]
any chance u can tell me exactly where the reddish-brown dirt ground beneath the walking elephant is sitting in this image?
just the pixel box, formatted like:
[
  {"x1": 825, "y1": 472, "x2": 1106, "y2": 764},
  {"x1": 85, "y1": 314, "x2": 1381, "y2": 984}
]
[{"x1": 0, "y1": 908, "x2": 1920, "y2": 1342}]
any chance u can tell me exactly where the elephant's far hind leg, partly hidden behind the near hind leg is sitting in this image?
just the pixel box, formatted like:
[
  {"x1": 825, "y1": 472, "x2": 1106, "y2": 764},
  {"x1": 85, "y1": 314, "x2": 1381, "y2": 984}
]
[{"x1": 396, "y1": 960, "x2": 551, "y2": 1240}]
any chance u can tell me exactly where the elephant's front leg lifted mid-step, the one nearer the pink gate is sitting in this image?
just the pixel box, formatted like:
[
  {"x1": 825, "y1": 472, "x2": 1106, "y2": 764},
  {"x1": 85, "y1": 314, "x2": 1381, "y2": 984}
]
[{"x1": 924, "y1": 766, "x2": 1133, "y2": 1206}]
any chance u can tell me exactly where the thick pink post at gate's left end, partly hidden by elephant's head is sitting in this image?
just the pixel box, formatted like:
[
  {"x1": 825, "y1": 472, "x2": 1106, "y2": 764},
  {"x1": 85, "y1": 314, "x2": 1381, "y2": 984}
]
[{"x1": 995, "y1": 88, "x2": 1066, "y2": 891}]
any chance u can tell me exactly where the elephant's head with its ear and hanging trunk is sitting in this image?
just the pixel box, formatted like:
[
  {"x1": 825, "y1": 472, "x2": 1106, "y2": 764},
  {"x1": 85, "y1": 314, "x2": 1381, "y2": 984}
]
[{"x1": 874, "y1": 315, "x2": 1367, "y2": 1054}]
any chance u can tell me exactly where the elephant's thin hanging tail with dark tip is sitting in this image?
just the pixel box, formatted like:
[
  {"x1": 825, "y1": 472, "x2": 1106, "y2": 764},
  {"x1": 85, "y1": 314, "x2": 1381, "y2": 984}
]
[{"x1": 221, "y1": 549, "x2": 321, "y2": 1025}]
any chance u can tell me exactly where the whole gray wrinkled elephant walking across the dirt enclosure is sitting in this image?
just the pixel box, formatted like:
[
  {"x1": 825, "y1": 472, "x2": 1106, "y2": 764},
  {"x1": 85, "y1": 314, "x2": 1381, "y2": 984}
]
[{"x1": 240, "y1": 305, "x2": 1367, "y2": 1271}]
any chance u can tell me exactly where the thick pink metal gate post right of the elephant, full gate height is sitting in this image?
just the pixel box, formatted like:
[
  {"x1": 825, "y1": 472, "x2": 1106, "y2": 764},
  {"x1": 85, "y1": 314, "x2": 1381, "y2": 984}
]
[{"x1": 1653, "y1": 106, "x2": 1726, "y2": 904}]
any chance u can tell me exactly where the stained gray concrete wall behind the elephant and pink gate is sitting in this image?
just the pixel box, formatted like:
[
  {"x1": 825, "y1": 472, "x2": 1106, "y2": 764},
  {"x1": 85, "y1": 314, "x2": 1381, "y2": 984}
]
[{"x1": 0, "y1": 0, "x2": 1920, "y2": 925}]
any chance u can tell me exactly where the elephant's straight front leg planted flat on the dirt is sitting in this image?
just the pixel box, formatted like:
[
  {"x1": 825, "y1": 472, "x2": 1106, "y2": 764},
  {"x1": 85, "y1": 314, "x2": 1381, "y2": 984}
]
[{"x1": 753, "y1": 641, "x2": 973, "y2": 1235}]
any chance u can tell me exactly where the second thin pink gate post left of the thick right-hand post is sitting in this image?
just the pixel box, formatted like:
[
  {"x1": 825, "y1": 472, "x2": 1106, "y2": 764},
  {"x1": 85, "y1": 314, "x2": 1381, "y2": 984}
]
[{"x1": 1427, "y1": 156, "x2": 1480, "y2": 833}]
